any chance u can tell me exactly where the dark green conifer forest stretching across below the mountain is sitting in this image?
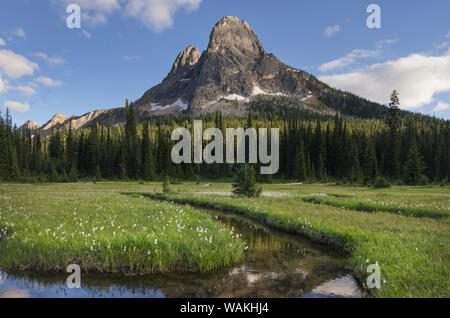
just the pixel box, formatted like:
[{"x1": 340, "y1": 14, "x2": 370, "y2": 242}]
[{"x1": 0, "y1": 95, "x2": 450, "y2": 184}]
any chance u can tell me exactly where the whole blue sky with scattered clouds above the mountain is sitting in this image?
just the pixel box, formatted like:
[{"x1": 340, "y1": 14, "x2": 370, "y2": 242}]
[{"x1": 0, "y1": 0, "x2": 450, "y2": 125}]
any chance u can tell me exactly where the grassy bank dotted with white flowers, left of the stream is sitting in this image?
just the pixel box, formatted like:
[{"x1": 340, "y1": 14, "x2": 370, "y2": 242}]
[{"x1": 0, "y1": 184, "x2": 245, "y2": 274}]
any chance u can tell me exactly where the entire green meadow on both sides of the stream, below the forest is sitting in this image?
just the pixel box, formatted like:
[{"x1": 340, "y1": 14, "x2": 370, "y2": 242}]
[{"x1": 0, "y1": 182, "x2": 450, "y2": 297}]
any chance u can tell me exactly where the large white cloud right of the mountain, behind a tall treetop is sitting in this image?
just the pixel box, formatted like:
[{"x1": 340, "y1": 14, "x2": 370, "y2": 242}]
[{"x1": 319, "y1": 50, "x2": 450, "y2": 109}]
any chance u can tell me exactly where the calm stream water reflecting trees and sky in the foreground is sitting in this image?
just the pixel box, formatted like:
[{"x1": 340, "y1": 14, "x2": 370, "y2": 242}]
[{"x1": 0, "y1": 213, "x2": 362, "y2": 297}]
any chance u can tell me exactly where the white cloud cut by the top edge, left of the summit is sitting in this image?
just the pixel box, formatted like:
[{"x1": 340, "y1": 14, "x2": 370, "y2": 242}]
[{"x1": 125, "y1": 0, "x2": 202, "y2": 32}]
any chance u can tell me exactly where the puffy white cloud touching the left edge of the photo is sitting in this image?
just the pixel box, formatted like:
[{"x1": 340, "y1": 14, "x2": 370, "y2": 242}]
[{"x1": 0, "y1": 50, "x2": 39, "y2": 79}]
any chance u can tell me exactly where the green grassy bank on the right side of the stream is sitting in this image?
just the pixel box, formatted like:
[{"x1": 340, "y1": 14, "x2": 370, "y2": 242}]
[{"x1": 145, "y1": 186, "x2": 450, "y2": 297}]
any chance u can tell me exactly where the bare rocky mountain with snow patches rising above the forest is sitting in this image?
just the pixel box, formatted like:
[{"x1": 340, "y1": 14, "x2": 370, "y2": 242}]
[{"x1": 134, "y1": 17, "x2": 320, "y2": 116}]
